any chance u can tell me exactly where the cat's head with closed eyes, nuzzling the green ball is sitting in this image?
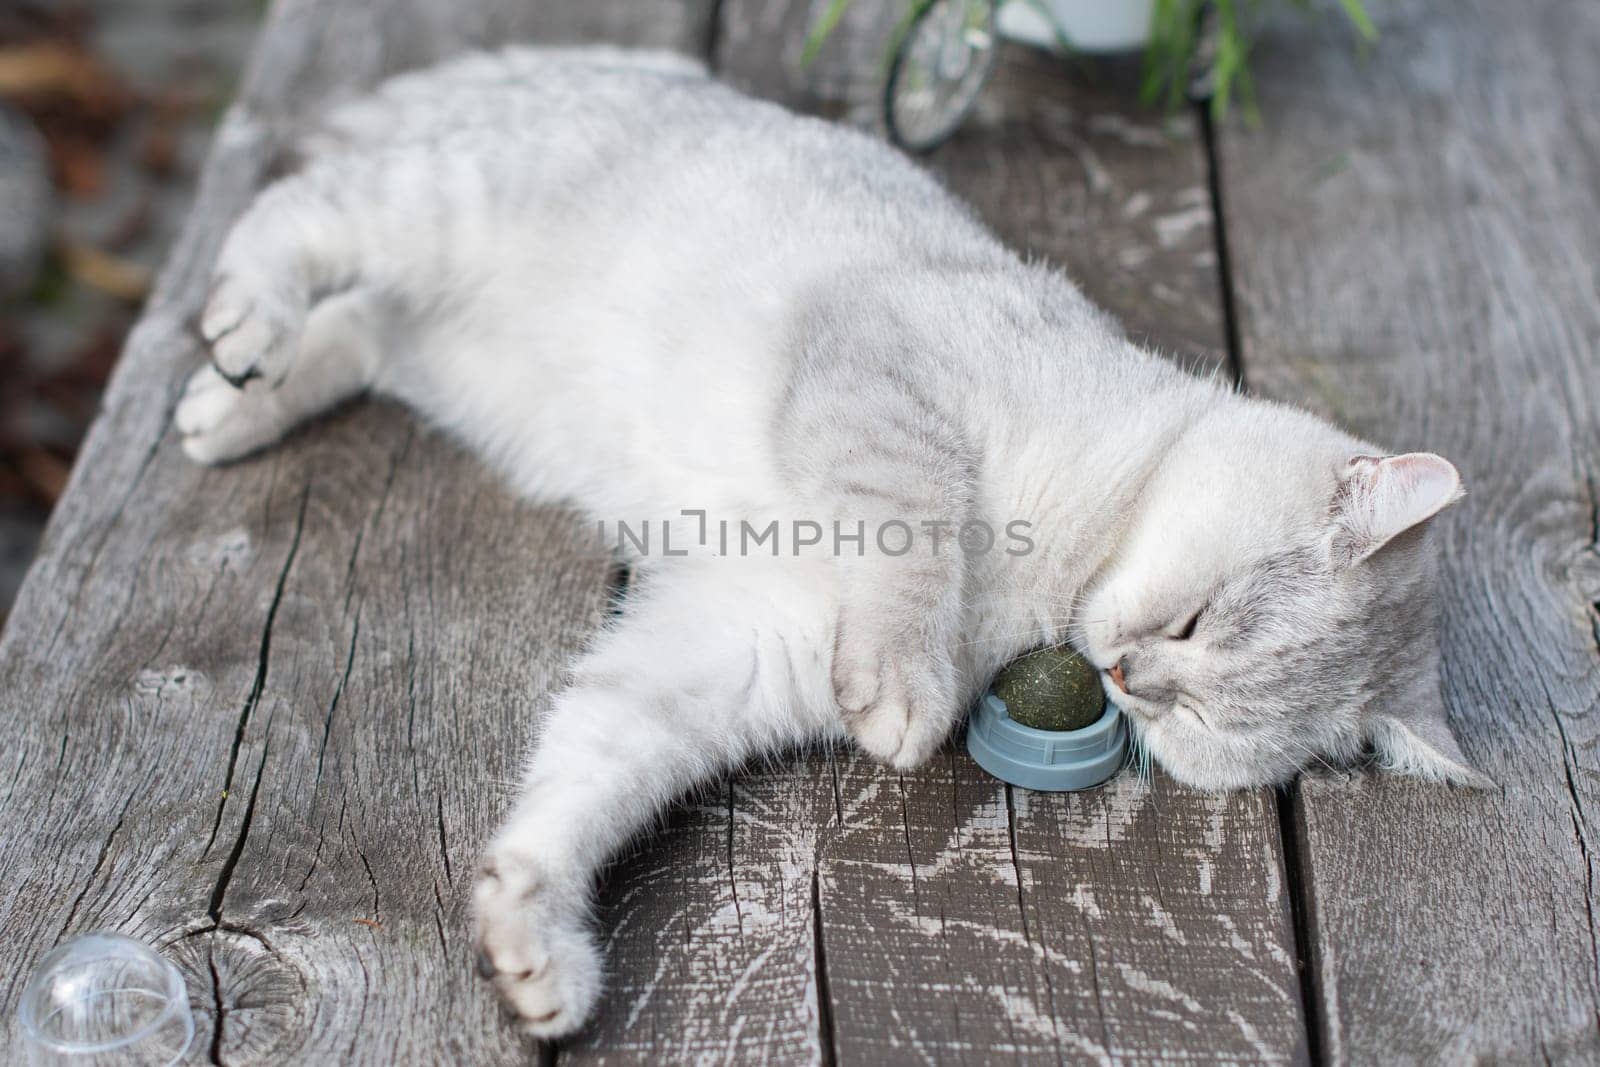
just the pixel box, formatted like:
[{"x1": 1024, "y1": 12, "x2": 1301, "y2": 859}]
[{"x1": 1077, "y1": 400, "x2": 1490, "y2": 789}]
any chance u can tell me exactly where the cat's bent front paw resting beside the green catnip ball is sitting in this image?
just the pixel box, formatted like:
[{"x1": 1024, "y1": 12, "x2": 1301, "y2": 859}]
[{"x1": 834, "y1": 640, "x2": 957, "y2": 771}]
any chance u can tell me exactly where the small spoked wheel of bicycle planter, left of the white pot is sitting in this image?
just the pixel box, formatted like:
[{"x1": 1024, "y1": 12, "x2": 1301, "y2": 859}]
[{"x1": 883, "y1": 0, "x2": 1000, "y2": 152}]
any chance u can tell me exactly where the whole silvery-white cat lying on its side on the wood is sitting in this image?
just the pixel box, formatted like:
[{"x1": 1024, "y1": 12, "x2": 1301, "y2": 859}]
[{"x1": 176, "y1": 50, "x2": 1483, "y2": 1035}]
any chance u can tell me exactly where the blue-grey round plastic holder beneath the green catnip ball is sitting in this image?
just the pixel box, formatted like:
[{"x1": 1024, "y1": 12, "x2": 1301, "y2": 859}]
[{"x1": 966, "y1": 693, "x2": 1128, "y2": 793}]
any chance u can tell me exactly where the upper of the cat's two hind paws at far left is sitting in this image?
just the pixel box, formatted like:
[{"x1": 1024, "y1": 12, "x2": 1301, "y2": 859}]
[{"x1": 200, "y1": 272, "x2": 306, "y2": 389}]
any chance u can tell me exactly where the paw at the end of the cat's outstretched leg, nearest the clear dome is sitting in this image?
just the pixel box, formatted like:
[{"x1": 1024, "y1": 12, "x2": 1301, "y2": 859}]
[{"x1": 472, "y1": 846, "x2": 602, "y2": 1038}]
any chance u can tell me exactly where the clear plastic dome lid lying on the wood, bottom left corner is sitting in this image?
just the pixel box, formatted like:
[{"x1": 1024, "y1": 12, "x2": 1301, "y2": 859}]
[{"x1": 16, "y1": 933, "x2": 195, "y2": 1067}]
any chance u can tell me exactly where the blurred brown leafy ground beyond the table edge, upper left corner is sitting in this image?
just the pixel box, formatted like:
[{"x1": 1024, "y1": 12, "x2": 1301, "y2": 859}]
[{"x1": 0, "y1": 0, "x2": 264, "y2": 625}]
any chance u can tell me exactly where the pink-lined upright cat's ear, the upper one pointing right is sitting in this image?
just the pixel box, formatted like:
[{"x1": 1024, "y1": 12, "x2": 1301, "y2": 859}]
[{"x1": 1333, "y1": 453, "x2": 1461, "y2": 565}]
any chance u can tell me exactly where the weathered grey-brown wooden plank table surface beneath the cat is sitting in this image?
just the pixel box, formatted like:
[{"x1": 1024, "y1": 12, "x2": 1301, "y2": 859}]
[{"x1": 0, "y1": 0, "x2": 1600, "y2": 1064}]
